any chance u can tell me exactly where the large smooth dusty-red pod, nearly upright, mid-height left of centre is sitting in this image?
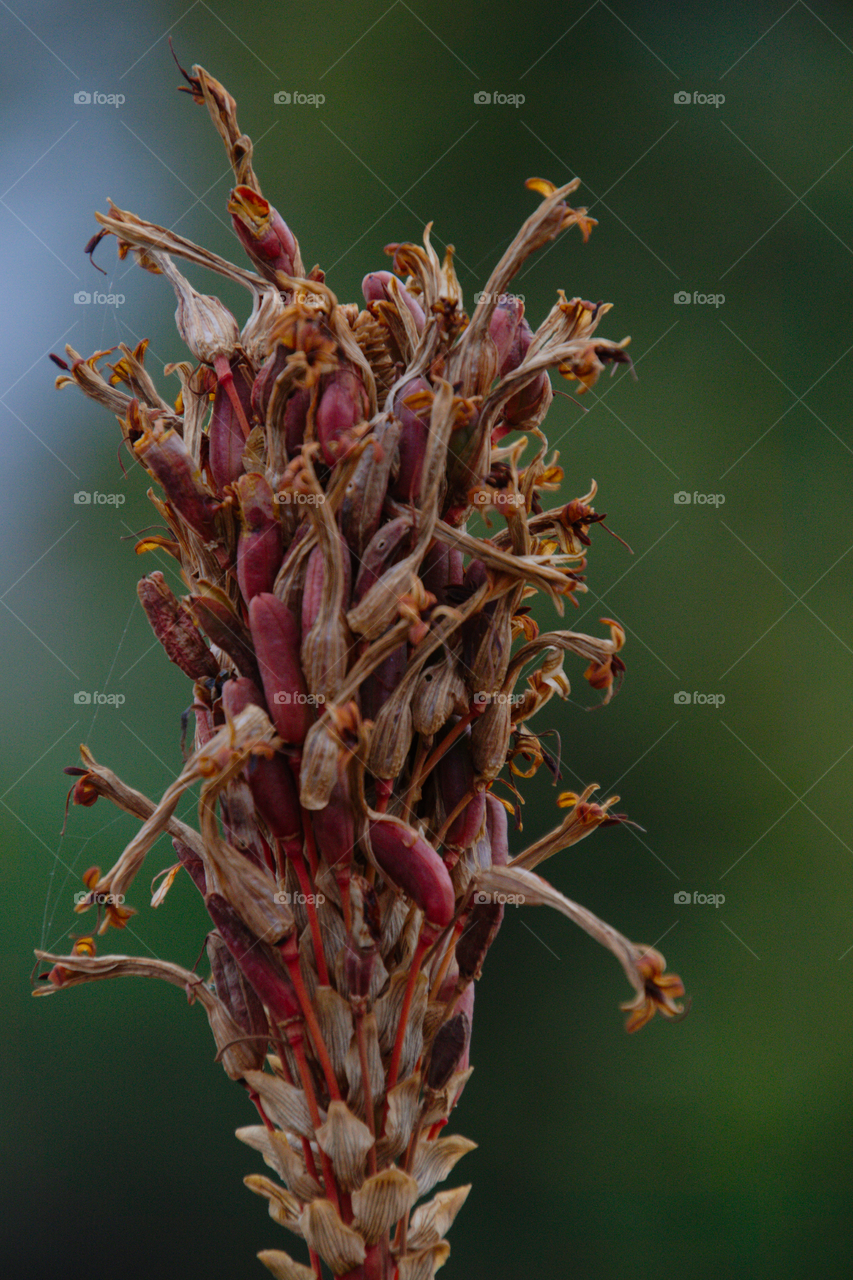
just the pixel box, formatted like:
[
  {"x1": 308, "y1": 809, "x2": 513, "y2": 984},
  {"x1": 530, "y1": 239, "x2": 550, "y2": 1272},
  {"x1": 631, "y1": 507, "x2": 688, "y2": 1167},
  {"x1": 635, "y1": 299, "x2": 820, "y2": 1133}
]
[{"x1": 248, "y1": 591, "x2": 314, "y2": 745}]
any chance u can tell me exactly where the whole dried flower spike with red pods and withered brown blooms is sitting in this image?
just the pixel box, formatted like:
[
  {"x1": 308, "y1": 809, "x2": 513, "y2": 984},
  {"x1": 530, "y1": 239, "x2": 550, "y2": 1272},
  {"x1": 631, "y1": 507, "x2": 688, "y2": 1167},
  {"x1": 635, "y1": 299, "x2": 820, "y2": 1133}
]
[{"x1": 38, "y1": 57, "x2": 684, "y2": 1280}]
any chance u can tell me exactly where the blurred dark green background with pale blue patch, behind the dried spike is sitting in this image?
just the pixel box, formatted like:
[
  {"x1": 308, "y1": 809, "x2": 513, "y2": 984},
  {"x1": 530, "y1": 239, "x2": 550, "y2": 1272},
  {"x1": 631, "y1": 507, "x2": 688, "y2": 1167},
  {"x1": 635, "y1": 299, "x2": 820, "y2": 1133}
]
[{"x1": 0, "y1": 0, "x2": 853, "y2": 1280}]
